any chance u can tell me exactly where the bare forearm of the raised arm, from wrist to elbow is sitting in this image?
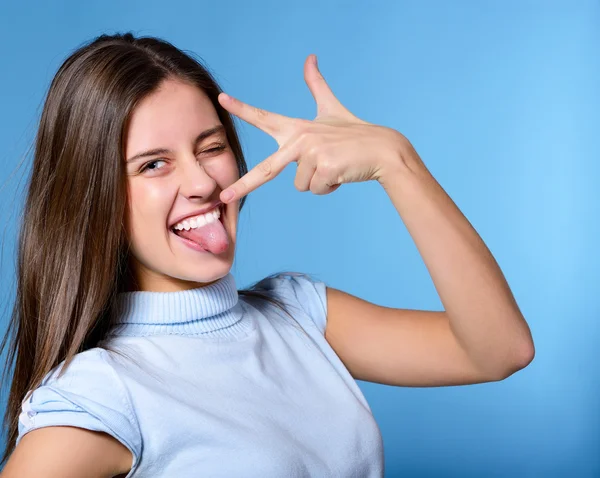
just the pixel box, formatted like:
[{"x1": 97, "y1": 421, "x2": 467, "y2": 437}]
[{"x1": 379, "y1": 136, "x2": 534, "y2": 377}]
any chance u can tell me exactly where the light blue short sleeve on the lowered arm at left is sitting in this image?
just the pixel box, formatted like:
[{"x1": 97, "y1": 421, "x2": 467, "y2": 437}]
[{"x1": 17, "y1": 348, "x2": 141, "y2": 469}]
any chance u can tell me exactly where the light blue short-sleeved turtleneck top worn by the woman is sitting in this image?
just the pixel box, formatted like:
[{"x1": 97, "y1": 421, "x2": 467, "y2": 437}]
[{"x1": 17, "y1": 272, "x2": 384, "y2": 478}]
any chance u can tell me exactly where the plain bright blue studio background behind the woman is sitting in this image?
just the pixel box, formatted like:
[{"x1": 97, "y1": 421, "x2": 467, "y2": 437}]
[{"x1": 0, "y1": 0, "x2": 600, "y2": 477}]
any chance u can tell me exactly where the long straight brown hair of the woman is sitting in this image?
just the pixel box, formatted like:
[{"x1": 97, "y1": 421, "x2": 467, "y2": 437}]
[{"x1": 0, "y1": 33, "x2": 300, "y2": 465}]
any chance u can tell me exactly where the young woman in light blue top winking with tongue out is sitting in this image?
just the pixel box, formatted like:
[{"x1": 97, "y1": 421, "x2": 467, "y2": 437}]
[{"x1": 2, "y1": 33, "x2": 534, "y2": 478}]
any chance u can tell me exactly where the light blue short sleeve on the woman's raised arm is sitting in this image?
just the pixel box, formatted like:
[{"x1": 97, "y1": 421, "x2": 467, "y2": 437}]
[{"x1": 261, "y1": 272, "x2": 327, "y2": 334}]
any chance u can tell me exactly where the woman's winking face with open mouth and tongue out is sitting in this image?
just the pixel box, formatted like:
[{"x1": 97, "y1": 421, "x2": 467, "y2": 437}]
[{"x1": 125, "y1": 80, "x2": 239, "y2": 292}]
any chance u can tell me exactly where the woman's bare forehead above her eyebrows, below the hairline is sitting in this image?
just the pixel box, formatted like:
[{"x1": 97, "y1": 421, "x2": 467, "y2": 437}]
[{"x1": 126, "y1": 79, "x2": 220, "y2": 157}]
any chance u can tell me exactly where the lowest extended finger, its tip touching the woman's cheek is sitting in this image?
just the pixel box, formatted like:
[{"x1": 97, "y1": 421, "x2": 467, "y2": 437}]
[{"x1": 220, "y1": 140, "x2": 298, "y2": 203}]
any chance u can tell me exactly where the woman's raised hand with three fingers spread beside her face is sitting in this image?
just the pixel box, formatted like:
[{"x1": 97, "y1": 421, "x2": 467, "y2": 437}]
[{"x1": 219, "y1": 55, "x2": 407, "y2": 202}]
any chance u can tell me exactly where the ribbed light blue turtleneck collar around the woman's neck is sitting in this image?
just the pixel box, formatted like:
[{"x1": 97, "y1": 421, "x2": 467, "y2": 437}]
[{"x1": 109, "y1": 273, "x2": 251, "y2": 337}]
